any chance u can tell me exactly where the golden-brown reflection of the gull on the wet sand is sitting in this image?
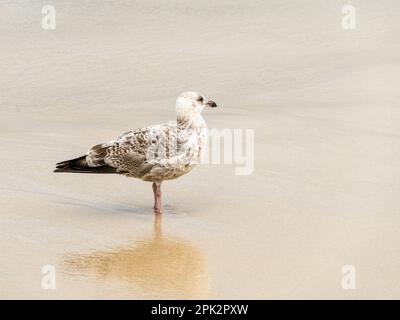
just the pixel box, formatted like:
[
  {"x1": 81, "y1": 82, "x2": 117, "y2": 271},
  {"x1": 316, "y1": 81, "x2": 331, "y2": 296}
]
[{"x1": 65, "y1": 215, "x2": 208, "y2": 299}]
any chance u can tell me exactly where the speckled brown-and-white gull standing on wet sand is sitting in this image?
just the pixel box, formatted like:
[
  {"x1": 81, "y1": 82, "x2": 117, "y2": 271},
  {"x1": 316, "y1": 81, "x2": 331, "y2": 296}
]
[{"x1": 54, "y1": 92, "x2": 217, "y2": 214}]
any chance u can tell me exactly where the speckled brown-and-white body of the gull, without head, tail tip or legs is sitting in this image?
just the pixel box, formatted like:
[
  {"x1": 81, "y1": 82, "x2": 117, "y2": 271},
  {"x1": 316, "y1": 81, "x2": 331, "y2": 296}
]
[{"x1": 86, "y1": 117, "x2": 207, "y2": 181}]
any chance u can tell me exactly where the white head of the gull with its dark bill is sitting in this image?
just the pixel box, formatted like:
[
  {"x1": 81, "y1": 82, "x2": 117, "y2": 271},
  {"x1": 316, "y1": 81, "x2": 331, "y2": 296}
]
[{"x1": 176, "y1": 91, "x2": 217, "y2": 119}]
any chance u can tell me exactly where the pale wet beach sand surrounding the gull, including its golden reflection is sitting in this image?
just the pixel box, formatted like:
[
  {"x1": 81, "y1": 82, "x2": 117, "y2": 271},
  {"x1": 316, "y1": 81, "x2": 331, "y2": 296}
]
[{"x1": 0, "y1": 0, "x2": 400, "y2": 299}]
